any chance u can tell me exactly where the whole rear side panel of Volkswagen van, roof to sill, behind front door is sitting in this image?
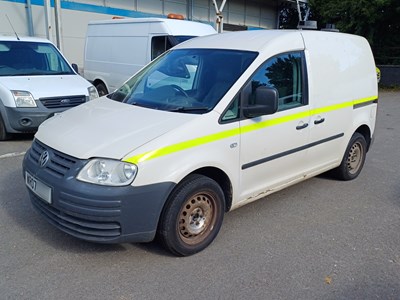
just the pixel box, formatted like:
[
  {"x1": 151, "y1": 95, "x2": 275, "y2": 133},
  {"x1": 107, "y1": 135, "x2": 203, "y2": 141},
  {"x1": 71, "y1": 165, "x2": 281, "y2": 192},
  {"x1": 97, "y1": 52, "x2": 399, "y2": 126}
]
[{"x1": 302, "y1": 32, "x2": 378, "y2": 175}]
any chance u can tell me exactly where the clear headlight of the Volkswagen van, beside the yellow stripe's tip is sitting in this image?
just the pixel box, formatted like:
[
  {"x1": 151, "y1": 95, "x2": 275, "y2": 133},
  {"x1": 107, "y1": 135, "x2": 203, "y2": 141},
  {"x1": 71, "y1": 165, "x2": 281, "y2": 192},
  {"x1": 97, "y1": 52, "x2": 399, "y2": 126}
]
[{"x1": 76, "y1": 158, "x2": 137, "y2": 186}]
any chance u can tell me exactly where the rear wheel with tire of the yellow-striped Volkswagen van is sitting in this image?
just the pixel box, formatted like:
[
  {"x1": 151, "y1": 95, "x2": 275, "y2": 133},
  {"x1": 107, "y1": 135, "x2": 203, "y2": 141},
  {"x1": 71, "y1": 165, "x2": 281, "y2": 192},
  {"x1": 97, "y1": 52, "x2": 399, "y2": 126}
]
[{"x1": 333, "y1": 132, "x2": 367, "y2": 180}]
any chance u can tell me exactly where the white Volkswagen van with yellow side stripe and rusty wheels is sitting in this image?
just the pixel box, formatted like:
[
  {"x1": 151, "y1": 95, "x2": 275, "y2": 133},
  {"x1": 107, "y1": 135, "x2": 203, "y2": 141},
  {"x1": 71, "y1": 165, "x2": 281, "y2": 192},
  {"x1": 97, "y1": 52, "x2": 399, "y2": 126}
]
[{"x1": 23, "y1": 30, "x2": 378, "y2": 255}]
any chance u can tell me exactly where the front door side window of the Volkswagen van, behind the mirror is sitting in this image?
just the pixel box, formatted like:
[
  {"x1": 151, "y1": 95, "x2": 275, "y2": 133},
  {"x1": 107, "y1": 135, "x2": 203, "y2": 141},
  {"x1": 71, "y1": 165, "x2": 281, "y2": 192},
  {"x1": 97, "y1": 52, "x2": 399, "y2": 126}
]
[{"x1": 244, "y1": 52, "x2": 307, "y2": 111}]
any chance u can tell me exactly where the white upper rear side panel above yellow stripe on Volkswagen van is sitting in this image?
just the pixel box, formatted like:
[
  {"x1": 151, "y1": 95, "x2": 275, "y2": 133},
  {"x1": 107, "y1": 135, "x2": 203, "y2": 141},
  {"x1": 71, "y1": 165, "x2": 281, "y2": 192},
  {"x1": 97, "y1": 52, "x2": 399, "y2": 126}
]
[{"x1": 302, "y1": 32, "x2": 378, "y2": 106}]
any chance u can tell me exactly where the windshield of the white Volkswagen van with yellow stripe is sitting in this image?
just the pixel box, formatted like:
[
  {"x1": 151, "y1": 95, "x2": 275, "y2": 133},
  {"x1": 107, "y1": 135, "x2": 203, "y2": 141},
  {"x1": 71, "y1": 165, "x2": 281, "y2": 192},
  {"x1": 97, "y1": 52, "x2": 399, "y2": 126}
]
[{"x1": 108, "y1": 49, "x2": 258, "y2": 113}]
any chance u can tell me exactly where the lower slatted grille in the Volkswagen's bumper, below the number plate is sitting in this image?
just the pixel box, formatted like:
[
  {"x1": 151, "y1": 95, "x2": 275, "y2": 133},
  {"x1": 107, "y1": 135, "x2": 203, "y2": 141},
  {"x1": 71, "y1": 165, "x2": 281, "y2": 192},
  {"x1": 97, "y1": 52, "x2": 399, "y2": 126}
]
[{"x1": 29, "y1": 192, "x2": 121, "y2": 242}]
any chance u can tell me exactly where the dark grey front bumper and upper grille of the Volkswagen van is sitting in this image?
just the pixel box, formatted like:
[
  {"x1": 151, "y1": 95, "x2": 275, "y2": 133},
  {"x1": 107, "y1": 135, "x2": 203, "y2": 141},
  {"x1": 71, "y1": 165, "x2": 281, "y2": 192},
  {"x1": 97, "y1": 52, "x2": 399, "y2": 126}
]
[{"x1": 23, "y1": 140, "x2": 175, "y2": 243}]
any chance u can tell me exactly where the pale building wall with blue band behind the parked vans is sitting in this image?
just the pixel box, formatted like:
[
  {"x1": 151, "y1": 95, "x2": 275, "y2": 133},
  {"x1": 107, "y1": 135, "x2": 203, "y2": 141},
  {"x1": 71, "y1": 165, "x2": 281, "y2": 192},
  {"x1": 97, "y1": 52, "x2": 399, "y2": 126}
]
[{"x1": 0, "y1": 0, "x2": 277, "y2": 68}]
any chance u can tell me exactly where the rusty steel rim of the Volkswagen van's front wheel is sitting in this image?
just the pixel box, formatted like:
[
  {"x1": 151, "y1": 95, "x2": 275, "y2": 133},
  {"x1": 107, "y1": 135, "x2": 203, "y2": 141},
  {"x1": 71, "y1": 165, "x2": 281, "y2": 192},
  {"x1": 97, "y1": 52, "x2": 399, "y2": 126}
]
[{"x1": 178, "y1": 192, "x2": 217, "y2": 245}]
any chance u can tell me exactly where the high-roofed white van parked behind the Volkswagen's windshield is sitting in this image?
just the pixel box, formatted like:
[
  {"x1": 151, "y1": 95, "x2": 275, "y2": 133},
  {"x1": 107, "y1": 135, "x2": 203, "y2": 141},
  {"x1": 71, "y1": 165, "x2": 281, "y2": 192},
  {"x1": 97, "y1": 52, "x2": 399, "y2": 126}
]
[{"x1": 84, "y1": 18, "x2": 216, "y2": 95}]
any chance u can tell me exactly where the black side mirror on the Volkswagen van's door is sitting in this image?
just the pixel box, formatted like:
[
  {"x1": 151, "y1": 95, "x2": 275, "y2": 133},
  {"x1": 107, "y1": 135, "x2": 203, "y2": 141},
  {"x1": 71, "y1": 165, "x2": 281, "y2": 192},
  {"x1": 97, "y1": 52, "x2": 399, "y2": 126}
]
[{"x1": 243, "y1": 86, "x2": 279, "y2": 118}]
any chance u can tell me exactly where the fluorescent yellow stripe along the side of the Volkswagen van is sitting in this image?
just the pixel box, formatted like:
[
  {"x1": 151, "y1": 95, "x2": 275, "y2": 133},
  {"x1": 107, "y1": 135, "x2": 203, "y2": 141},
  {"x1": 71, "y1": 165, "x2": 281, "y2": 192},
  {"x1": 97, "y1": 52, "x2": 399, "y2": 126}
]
[{"x1": 124, "y1": 96, "x2": 378, "y2": 164}]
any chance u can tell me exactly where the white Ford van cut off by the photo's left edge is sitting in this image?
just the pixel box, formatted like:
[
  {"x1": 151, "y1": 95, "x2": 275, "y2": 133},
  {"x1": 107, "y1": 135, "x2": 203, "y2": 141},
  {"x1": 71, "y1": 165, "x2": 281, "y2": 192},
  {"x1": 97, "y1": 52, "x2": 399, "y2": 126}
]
[{"x1": 0, "y1": 36, "x2": 98, "y2": 141}]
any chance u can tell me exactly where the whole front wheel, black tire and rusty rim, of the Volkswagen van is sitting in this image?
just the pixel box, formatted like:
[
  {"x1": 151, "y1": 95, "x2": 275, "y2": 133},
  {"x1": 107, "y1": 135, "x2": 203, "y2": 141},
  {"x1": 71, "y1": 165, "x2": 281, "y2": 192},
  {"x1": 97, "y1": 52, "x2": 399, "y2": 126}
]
[{"x1": 158, "y1": 174, "x2": 225, "y2": 256}]
